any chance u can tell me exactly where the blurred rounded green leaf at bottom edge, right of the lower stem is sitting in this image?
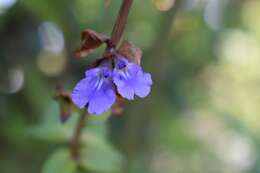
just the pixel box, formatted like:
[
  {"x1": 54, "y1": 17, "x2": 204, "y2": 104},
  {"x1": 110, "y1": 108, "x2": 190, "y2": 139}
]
[{"x1": 81, "y1": 139, "x2": 122, "y2": 173}]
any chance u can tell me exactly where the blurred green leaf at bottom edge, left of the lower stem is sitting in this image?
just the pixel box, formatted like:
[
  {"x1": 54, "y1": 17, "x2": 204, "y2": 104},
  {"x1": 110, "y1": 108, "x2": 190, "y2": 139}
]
[{"x1": 42, "y1": 149, "x2": 77, "y2": 173}]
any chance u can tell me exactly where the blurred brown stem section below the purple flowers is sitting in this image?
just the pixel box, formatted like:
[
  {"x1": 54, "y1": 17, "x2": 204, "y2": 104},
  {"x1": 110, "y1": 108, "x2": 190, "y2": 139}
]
[{"x1": 70, "y1": 111, "x2": 87, "y2": 160}]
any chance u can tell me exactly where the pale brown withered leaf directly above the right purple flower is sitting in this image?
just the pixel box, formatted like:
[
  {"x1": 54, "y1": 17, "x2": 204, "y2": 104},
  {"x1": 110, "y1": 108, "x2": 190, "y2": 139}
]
[{"x1": 118, "y1": 40, "x2": 142, "y2": 64}]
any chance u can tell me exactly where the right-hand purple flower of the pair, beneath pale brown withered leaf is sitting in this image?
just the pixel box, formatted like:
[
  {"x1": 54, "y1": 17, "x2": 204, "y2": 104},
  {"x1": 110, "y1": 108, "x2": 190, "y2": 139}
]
[{"x1": 113, "y1": 55, "x2": 152, "y2": 100}]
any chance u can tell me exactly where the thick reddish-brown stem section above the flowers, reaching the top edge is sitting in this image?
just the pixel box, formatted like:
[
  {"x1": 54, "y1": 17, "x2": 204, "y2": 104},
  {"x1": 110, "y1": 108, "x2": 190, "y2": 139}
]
[{"x1": 111, "y1": 0, "x2": 133, "y2": 47}]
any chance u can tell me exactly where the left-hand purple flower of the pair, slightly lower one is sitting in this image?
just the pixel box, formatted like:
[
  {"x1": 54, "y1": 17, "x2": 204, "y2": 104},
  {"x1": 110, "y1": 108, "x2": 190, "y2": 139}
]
[{"x1": 72, "y1": 66, "x2": 116, "y2": 114}]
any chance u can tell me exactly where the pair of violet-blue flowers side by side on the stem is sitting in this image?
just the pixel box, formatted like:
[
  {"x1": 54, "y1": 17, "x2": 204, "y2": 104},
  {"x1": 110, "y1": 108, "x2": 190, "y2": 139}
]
[{"x1": 72, "y1": 54, "x2": 152, "y2": 115}]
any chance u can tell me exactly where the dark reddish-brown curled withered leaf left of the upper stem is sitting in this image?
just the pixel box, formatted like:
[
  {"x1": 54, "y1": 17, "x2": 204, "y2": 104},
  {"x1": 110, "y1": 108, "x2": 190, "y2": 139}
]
[{"x1": 75, "y1": 29, "x2": 109, "y2": 58}]
